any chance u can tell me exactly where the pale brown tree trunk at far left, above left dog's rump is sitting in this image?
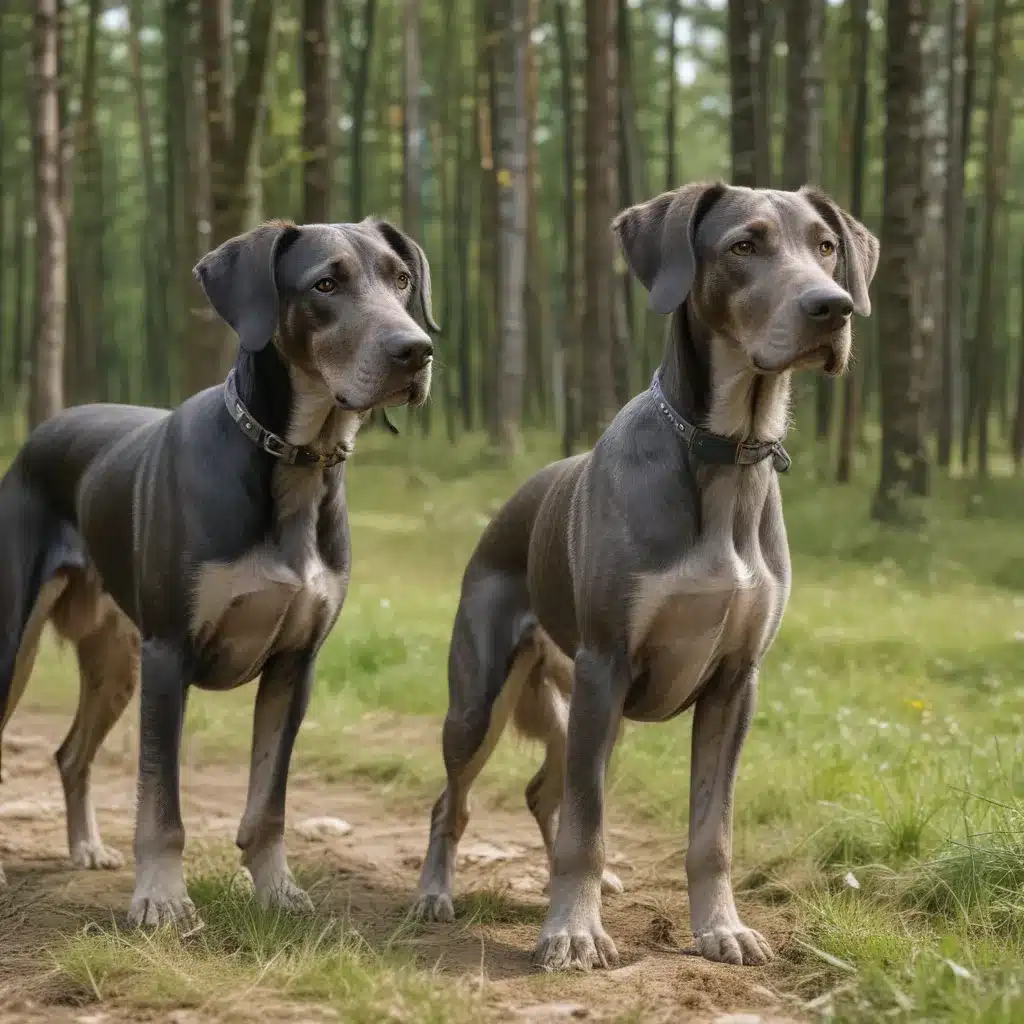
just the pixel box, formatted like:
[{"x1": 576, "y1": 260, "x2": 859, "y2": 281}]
[{"x1": 29, "y1": 0, "x2": 68, "y2": 427}]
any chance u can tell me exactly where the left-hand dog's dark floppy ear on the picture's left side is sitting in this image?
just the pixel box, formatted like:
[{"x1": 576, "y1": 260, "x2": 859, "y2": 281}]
[{"x1": 193, "y1": 220, "x2": 299, "y2": 352}]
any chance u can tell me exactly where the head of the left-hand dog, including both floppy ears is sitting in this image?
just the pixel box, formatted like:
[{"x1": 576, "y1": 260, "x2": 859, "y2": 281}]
[{"x1": 195, "y1": 218, "x2": 437, "y2": 412}]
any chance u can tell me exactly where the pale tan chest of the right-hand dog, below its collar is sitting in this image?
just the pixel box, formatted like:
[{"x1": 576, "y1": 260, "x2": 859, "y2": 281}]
[{"x1": 630, "y1": 471, "x2": 788, "y2": 720}]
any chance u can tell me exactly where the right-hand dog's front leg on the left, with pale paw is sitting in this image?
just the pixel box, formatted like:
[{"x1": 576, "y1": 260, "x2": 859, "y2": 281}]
[{"x1": 534, "y1": 648, "x2": 629, "y2": 971}]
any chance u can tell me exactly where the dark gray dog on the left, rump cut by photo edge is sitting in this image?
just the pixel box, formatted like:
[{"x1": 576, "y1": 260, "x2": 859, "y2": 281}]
[{"x1": 0, "y1": 219, "x2": 436, "y2": 925}]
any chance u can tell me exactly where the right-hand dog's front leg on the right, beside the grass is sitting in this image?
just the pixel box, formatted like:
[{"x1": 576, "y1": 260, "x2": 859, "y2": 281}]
[{"x1": 686, "y1": 666, "x2": 773, "y2": 964}]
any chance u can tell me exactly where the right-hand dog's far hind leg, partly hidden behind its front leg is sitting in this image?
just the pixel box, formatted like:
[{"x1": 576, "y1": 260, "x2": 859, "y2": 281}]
[{"x1": 515, "y1": 627, "x2": 623, "y2": 894}]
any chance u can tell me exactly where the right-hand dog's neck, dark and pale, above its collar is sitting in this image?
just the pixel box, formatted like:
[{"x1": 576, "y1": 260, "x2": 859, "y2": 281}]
[{"x1": 660, "y1": 302, "x2": 790, "y2": 441}]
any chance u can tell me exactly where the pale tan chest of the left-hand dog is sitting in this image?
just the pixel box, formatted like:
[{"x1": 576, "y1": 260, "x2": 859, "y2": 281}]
[{"x1": 191, "y1": 470, "x2": 348, "y2": 689}]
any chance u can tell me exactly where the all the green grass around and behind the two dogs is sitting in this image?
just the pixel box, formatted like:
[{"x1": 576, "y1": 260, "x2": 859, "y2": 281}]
[{"x1": 19, "y1": 421, "x2": 1024, "y2": 1022}]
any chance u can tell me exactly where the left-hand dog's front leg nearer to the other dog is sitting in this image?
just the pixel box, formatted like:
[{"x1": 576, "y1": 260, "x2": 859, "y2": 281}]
[{"x1": 234, "y1": 654, "x2": 314, "y2": 911}]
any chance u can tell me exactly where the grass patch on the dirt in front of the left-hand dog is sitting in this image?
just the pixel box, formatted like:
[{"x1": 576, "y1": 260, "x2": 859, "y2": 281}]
[{"x1": 55, "y1": 876, "x2": 474, "y2": 1024}]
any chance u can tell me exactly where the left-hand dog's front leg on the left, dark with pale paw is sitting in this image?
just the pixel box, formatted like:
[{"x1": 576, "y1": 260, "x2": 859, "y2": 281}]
[{"x1": 129, "y1": 640, "x2": 196, "y2": 927}]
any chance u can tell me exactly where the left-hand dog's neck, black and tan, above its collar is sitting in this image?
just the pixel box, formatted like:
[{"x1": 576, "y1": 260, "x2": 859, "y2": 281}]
[{"x1": 234, "y1": 343, "x2": 365, "y2": 453}]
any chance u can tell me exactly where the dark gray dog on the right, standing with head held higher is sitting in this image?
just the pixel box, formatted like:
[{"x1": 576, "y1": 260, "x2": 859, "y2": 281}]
[{"x1": 415, "y1": 184, "x2": 879, "y2": 970}]
